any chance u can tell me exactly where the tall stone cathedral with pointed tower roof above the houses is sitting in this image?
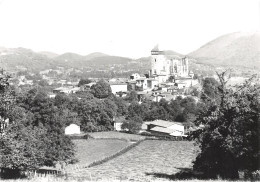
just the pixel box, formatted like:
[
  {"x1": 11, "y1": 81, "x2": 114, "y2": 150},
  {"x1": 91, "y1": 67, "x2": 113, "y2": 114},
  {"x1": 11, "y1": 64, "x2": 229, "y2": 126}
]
[{"x1": 149, "y1": 46, "x2": 192, "y2": 83}]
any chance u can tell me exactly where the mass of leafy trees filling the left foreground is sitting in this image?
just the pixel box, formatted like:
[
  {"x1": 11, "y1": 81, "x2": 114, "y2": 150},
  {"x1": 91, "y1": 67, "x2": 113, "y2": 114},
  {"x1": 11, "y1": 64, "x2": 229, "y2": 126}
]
[{"x1": 0, "y1": 75, "x2": 76, "y2": 174}]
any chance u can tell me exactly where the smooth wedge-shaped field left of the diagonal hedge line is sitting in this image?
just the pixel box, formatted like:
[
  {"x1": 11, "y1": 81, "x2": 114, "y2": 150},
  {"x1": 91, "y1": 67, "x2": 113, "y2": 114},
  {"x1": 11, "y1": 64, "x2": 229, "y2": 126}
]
[{"x1": 67, "y1": 139, "x2": 129, "y2": 170}]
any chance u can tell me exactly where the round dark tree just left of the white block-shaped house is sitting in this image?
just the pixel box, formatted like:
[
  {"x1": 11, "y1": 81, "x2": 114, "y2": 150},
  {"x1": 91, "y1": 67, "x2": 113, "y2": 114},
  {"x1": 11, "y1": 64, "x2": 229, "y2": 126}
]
[{"x1": 91, "y1": 79, "x2": 112, "y2": 99}]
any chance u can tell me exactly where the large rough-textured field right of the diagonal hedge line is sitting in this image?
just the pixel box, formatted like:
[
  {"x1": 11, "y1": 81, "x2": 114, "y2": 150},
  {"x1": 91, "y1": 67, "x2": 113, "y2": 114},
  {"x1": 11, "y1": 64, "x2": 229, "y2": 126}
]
[{"x1": 69, "y1": 140, "x2": 196, "y2": 181}]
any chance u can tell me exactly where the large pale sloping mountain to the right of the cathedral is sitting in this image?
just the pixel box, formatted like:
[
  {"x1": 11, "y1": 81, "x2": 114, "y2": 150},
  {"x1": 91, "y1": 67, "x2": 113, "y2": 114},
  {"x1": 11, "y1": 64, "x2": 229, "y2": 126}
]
[{"x1": 188, "y1": 32, "x2": 260, "y2": 68}]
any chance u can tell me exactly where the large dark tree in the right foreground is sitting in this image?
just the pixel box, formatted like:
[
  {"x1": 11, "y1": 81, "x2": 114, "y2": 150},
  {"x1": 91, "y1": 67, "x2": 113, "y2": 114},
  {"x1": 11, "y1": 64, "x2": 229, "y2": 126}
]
[{"x1": 192, "y1": 72, "x2": 260, "y2": 179}]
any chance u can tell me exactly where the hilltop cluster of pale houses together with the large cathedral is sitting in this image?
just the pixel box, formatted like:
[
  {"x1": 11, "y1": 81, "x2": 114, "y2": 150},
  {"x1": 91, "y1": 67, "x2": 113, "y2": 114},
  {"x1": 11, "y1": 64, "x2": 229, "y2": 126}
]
[{"x1": 109, "y1": 46, "x2": 199, "y2": 102}]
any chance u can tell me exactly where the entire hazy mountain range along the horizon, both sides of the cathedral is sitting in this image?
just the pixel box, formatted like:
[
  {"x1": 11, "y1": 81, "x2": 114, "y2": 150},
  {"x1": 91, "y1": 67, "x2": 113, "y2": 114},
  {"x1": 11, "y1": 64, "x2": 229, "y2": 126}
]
[{"x1": 0, "y1": 32, "x2": 260, "y2": 71}]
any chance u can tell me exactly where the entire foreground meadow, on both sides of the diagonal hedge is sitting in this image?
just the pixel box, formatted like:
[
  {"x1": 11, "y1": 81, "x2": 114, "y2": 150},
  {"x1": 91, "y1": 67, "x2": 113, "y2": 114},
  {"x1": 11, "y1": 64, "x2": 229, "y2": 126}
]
[{"x1": 1, "y1": 132, "x2": 255, "y2": 182}]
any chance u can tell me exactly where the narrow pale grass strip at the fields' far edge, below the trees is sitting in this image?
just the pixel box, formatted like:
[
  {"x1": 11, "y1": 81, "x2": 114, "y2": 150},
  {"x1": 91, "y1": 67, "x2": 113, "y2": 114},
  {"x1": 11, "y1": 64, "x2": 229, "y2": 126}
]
[{"x1": 88, "y1": 131, "x2": 145, "y2": 141}]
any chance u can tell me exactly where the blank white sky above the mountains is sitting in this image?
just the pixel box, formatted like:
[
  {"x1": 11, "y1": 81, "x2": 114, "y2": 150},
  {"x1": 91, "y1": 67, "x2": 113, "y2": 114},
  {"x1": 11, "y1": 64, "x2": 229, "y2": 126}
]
[{"x1": 0, "y1": 0, "x2": 260, "y2": 58}]
